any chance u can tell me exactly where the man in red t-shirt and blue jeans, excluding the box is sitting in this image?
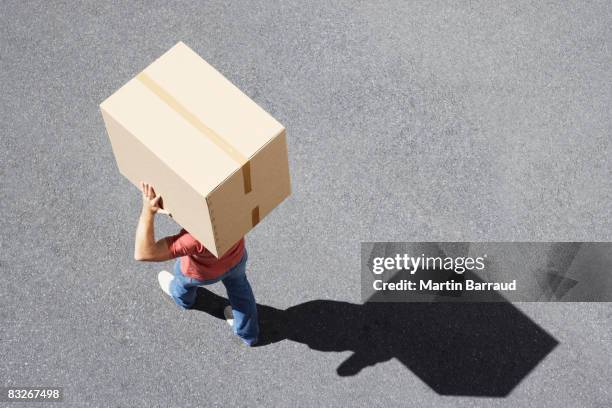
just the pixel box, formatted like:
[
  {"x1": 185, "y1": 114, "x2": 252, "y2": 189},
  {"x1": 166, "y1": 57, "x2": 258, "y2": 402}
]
[{"x1": 134, "y1": 182, "x2": 259, "y2": 346}]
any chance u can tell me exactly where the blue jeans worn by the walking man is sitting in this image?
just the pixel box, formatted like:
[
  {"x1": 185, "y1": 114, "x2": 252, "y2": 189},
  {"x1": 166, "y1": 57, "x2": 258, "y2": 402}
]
[{"x1": 170, "y1": 250, "x2": 259, "y2": 346}]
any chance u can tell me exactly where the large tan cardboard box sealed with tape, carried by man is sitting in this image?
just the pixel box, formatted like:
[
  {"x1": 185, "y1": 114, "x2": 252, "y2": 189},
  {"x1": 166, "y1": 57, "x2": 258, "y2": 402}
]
[{"x1": 100, "y1": 42, "x2": 291, "y2": 257}]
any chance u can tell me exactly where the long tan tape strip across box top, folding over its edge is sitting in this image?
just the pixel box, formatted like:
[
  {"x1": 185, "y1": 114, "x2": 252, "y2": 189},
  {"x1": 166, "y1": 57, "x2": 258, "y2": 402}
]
[{"x1": 136, "y1": 72, "x2": 252, "y2": 194}]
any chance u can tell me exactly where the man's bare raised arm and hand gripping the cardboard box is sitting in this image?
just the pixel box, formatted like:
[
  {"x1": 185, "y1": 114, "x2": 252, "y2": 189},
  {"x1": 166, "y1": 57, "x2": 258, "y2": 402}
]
[{"x1": 134, "y1": 182, "x2": 173, "y2": 261}]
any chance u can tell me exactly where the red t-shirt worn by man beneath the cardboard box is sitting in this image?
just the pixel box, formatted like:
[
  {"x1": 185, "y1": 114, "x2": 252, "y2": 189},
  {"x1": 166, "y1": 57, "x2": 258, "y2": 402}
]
[{"x1": 166, "y1": 229, "x2": 244, "y2": 280}]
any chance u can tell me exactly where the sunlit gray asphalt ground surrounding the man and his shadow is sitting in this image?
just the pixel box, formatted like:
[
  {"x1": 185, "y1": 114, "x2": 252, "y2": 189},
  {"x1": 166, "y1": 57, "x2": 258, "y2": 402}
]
[{"x1": 0, "y1": 1, "x2": 612, "y2": 407}]
